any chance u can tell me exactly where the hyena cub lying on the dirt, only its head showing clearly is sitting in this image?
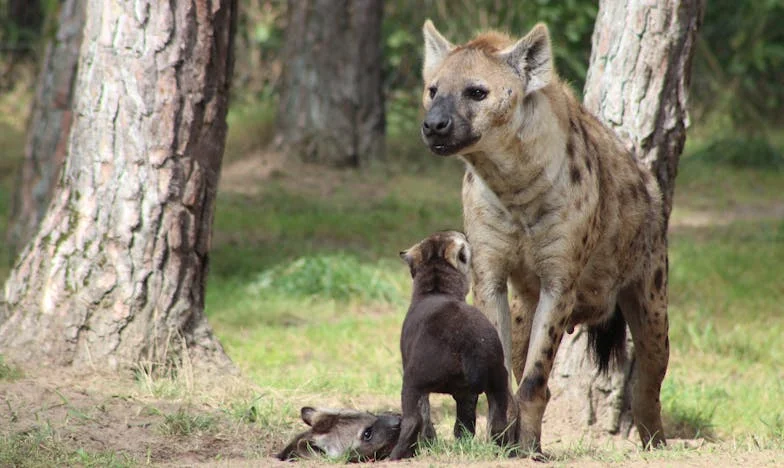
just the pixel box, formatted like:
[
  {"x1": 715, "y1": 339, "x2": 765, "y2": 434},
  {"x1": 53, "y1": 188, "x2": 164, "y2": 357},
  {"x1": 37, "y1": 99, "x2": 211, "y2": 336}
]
[{"x1": 277, "y1": 406, "x2": 400, "y2": 462}]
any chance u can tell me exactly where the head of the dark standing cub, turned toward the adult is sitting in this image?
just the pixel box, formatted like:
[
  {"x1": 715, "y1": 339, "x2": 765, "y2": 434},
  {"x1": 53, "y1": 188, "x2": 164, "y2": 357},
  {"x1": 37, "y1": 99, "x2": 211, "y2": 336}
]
[{"x1": 400, "y1": 231, "x2": 471, "y2": 288}]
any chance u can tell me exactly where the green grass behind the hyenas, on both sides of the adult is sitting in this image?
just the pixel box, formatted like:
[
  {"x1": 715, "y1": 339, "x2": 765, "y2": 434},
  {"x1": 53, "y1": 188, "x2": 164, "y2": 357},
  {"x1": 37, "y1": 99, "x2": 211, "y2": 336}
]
[{"x1": 202, "y1": 123, "x2": 784, "y2": 450}]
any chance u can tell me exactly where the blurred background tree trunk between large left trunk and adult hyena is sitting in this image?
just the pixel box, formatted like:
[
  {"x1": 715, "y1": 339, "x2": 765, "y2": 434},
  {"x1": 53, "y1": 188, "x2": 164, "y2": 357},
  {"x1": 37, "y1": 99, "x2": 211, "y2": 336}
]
[{"x1": 278, "y1": 0, "x2": 384, "y2": 167}]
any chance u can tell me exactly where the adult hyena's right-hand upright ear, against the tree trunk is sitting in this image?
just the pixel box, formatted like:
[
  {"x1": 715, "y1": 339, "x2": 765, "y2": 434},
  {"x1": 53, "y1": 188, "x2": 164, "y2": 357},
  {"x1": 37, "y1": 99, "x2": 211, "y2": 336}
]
[{"x1": 500, "y1": 23, "x2": 553, "y2": 94}]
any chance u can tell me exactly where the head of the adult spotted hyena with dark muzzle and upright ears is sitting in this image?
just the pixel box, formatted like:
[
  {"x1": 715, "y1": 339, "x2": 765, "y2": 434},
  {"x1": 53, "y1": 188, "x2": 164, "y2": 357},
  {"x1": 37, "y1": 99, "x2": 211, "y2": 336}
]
[{"x1": 422, "y1": 20, "x2": 554, "y2": 156}]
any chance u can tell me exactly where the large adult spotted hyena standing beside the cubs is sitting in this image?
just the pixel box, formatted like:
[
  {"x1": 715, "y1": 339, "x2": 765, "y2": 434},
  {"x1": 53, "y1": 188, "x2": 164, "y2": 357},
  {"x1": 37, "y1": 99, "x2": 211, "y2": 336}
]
[{"x1": 422, "y1": 21, "x2": 669, "y2": 450}]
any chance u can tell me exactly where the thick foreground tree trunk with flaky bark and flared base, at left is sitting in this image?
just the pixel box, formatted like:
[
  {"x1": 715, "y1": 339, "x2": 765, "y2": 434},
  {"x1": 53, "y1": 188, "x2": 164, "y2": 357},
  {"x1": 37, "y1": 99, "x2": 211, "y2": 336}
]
[{"x1": 0, "y1": 0, "x2": 237, "y2": 368}]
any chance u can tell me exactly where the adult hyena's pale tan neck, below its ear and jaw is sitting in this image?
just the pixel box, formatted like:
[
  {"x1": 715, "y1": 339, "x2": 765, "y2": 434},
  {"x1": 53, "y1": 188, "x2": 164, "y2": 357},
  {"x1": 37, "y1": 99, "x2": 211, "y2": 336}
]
[{"x1": 464, "y1": 85, "x2": 568, "y2": 207}]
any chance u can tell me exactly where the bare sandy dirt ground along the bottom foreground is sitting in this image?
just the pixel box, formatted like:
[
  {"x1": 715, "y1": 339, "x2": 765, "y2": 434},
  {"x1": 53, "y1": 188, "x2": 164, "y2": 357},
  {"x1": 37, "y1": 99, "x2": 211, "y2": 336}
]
[{"x1": 0, "y1": 369, "x2": 784, "y2": 467}]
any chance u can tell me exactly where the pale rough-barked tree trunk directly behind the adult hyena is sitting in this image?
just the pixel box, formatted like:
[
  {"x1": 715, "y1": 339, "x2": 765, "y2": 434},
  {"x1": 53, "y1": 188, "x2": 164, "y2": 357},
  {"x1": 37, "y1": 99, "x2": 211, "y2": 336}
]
[{"x1": 551, "y1": 0, "x2": 704, "y2": 436}]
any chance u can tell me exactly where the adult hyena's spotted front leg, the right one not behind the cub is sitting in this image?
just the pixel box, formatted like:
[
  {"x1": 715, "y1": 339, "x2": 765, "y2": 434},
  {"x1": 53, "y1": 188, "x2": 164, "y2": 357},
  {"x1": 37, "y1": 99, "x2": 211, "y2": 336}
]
[{"x1": 517, "y1": 286, "x2": 576, "y2": 453}]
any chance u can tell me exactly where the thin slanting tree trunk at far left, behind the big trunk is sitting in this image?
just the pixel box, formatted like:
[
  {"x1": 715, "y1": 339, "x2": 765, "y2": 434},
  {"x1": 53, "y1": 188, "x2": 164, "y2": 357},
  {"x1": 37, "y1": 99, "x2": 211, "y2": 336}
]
[{"x1": 6, "y1": 0, "x2": 85, "y2": 258}]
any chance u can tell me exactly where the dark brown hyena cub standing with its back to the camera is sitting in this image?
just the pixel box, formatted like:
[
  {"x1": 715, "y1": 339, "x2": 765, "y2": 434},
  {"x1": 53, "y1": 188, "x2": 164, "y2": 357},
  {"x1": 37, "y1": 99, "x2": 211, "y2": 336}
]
[{"x1": 390, "y1": 231, "x2": 509, "y2": 460}]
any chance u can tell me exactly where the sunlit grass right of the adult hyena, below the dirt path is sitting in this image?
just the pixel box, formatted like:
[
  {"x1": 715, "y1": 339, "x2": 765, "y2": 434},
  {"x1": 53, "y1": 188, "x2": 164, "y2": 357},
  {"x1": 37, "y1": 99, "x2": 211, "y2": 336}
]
[{"x1": 663, "y1": 220, "x2": 784, "y2": 437}]
